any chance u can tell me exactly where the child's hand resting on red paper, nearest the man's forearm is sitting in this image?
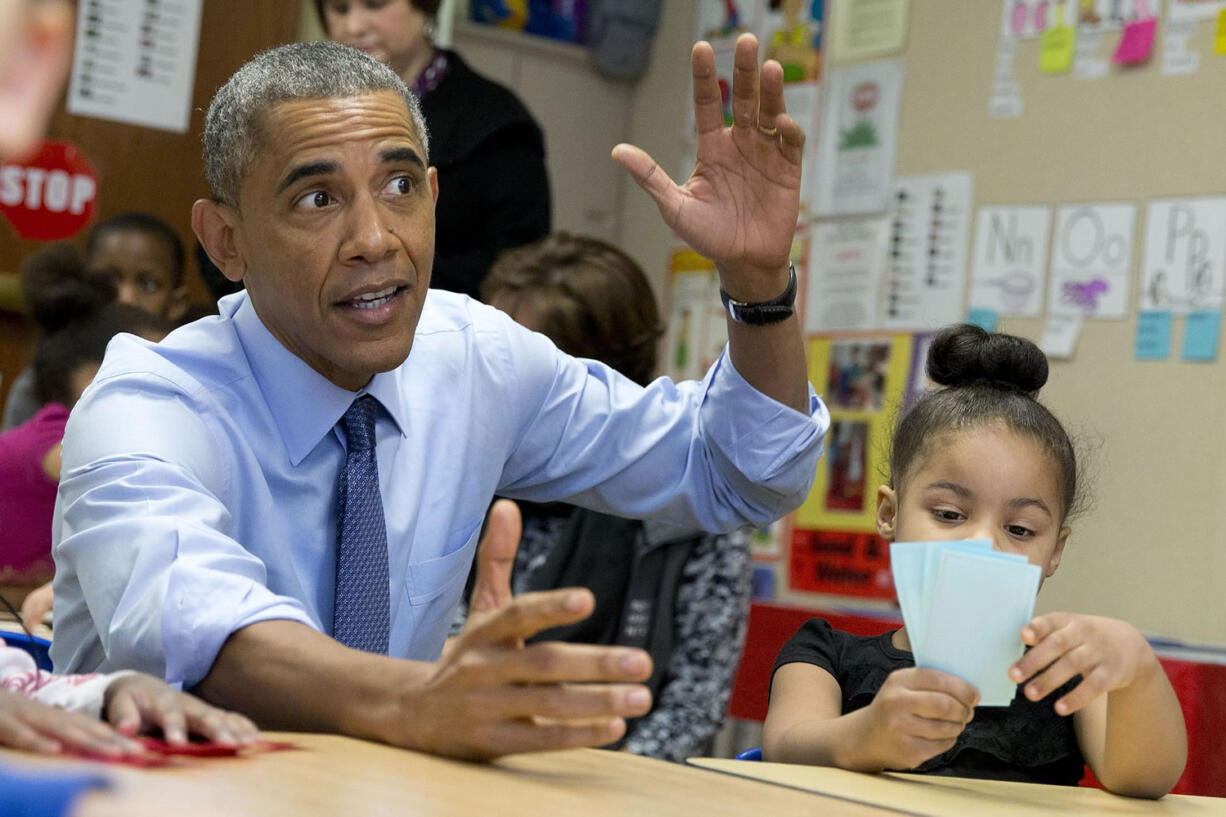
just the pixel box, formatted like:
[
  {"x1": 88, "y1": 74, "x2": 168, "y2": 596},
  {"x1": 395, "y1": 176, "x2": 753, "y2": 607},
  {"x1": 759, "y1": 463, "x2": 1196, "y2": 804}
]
[{"x1": 103, "y1": 672, "x2": 260, "y2": 746}]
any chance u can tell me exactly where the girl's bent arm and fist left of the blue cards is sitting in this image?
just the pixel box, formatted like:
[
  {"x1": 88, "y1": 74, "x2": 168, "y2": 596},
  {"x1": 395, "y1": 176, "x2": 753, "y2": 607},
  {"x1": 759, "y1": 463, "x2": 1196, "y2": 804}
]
[{"x1": 763, "y1": 662, "x2": 978, "y2": 772}]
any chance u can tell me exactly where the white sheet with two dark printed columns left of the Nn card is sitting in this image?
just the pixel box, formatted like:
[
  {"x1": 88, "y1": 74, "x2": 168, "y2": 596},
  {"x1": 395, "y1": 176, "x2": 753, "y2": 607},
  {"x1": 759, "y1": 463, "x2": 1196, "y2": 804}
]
[{"x1": 881, "y1": 173, "x2": 971, "y2": 330}]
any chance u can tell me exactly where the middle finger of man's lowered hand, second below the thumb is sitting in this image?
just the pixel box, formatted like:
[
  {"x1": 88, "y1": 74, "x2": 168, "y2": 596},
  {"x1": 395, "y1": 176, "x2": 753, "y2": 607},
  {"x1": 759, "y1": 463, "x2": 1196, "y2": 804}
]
[{"x1": 461, "y1": 642, "x2": 651, "y2": 686}]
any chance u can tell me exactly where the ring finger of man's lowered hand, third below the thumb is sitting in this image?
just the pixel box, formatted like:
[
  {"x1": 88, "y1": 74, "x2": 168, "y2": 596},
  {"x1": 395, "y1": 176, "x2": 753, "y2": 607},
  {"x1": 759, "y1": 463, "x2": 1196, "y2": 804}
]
[{"x1": 463, "y1": 683, "x2": 651, "y2": 721}]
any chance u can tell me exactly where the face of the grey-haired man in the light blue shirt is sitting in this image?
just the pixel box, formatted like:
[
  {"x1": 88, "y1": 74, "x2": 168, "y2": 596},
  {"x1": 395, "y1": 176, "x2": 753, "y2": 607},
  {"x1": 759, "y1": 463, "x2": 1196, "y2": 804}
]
[{"x1": 223, "y1": 91, "x2": 438, "y2": 390}]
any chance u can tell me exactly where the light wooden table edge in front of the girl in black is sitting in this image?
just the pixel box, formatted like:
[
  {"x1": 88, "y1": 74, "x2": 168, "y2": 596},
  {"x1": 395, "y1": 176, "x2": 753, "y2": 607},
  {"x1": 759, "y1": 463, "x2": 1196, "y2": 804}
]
[{"x1": 689, "y1": 758, "x2": 1226, "y2": 817}]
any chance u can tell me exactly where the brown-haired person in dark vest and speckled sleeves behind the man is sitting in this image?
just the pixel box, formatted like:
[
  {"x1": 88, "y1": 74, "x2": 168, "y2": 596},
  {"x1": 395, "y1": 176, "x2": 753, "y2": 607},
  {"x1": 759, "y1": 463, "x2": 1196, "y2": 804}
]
[{"x1": 454, "y1": 233, "x2": 750, "y2": 761}]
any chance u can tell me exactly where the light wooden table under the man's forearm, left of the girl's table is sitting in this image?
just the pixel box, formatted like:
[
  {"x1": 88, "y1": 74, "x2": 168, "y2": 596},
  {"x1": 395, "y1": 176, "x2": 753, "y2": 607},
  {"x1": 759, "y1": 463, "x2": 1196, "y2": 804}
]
[{"x1": 0, "y1": 734, "x2": 897, "y2": 817}]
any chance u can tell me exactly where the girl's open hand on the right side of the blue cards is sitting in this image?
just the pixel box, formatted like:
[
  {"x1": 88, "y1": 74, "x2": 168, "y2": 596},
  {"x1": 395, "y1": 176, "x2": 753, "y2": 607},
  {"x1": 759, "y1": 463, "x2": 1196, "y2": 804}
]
[{"x1": 1009, "y1": 612, "x2": 1162, "y2": 715}]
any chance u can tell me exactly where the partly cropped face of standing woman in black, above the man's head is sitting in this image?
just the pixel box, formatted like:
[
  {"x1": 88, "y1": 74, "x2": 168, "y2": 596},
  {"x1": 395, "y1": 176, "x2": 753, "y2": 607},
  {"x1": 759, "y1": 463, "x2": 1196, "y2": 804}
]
[{"x1": 324, "y1": 0, "x2": 430, "y2": 79}]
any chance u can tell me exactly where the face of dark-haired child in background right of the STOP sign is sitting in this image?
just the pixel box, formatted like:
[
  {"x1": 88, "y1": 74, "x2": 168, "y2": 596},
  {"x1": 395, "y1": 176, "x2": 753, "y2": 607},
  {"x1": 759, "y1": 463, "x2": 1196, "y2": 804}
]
[{"x1": 86, "y1": 229, "x2": 188, "y2": 320}]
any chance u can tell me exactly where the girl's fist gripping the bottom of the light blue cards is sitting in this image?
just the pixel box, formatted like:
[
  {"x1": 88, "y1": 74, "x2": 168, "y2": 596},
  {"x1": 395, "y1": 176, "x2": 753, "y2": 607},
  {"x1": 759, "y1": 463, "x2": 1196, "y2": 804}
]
[{"x1": 848, "y1": 667, "x2": 980, "y2": 769}]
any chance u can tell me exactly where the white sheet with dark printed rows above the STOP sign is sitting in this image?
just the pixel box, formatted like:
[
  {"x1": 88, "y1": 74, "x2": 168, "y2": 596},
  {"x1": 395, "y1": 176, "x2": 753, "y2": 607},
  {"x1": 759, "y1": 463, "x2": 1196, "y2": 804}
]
[{"x1": 67, "y1": 0, "x2": 204, "y2": 134}]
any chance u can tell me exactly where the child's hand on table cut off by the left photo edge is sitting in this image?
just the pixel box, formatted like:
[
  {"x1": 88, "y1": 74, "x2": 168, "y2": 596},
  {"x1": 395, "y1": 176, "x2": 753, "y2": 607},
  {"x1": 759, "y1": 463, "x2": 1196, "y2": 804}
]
[{"x1": 0, "y1": 689, "x2": 145, "y2": 757}]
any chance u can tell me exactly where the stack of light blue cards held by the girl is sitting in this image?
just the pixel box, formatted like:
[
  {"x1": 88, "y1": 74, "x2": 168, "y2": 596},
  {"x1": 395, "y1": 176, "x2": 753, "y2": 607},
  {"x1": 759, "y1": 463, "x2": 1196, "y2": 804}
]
[{"x1": 890, "y1": 539, "x2": 1040, "y2": 707}]
